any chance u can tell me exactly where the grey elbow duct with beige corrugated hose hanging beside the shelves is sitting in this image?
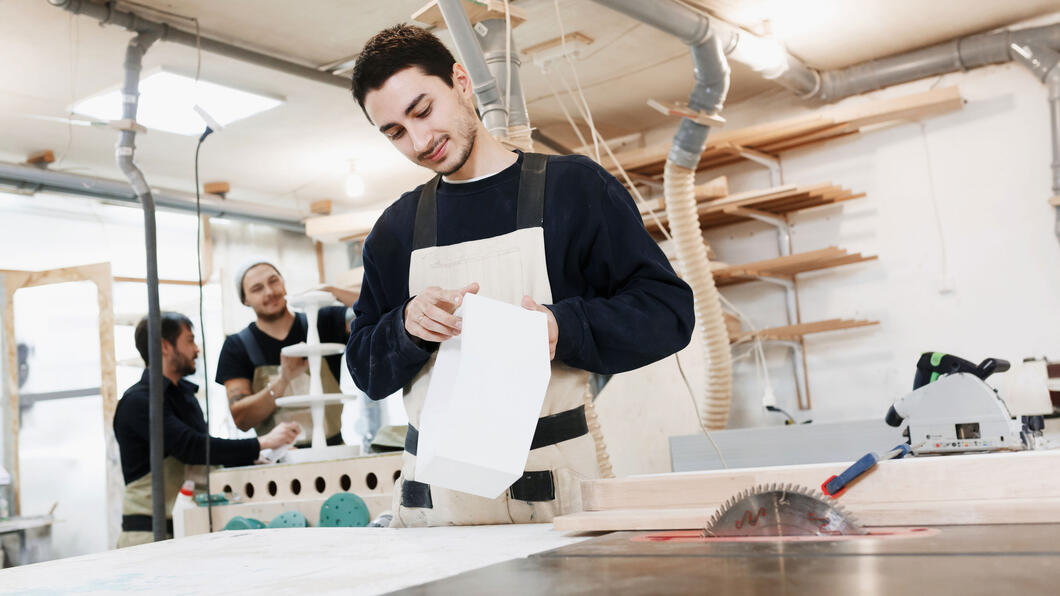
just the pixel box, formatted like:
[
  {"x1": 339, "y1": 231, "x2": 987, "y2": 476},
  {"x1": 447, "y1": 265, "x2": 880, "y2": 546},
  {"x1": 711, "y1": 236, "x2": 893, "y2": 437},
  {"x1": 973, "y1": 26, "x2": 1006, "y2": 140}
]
[{"x1": 595, "y1": 0, "x2": 733, "y2": 430}]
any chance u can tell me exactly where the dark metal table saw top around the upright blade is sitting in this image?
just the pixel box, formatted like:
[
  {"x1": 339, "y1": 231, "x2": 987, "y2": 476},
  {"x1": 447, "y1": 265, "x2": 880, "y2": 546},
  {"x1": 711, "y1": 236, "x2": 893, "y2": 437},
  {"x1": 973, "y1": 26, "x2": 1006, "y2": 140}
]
[{"x1": 396, "y1": 524, "x2": 1060, "y2": 596}]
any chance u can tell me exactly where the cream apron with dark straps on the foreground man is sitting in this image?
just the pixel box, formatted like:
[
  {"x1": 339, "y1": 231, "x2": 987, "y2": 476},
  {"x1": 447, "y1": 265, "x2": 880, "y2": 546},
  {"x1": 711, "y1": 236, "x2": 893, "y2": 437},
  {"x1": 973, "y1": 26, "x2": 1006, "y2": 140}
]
[{"x1": 391, "y1": 153, "x2": 599, "y2": 527}]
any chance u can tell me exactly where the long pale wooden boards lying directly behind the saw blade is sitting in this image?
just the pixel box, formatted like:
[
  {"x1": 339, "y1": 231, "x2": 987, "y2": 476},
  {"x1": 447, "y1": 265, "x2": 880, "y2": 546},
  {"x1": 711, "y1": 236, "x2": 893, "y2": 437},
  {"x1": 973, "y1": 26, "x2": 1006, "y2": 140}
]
[{"x1": 553, "y1": 451, "x2": 1060, "y2": 531}]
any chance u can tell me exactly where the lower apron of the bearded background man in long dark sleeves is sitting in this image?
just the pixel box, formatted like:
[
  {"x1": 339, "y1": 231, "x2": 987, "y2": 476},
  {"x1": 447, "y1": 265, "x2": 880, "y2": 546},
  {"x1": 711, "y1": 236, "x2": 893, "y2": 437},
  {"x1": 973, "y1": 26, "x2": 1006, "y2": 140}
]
[{"x1": 118, "y1": 455, "x2": 206, "y2": 548}]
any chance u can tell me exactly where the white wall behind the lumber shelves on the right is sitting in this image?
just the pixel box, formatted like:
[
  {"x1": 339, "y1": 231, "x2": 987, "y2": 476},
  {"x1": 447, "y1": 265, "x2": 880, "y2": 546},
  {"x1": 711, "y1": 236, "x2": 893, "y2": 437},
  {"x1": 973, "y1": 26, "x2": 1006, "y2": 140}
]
[{"x1": 678, "y1": 56, "x2": 1060, "y2": 427}]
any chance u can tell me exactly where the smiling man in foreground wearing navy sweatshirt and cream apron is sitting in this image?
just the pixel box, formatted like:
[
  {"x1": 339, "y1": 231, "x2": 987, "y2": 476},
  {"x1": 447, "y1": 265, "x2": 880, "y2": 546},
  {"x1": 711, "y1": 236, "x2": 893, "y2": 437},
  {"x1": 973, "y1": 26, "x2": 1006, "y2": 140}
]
[{"x1": 347, "y1": 25, "x2": 694, "y2": 527}]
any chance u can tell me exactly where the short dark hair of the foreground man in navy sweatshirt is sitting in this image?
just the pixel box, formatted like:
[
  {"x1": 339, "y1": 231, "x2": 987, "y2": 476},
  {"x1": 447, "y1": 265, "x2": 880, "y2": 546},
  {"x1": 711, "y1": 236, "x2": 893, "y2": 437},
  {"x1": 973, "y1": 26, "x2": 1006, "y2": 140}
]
[{"x1": 353, "y1": 23, "x2": 457, "y2": 120}]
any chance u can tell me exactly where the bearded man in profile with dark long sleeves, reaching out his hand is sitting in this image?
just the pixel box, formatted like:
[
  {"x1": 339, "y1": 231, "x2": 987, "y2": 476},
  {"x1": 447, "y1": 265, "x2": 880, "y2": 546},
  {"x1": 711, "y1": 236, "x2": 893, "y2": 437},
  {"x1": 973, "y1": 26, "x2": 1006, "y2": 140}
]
[{"x1": 113, "y1": 312, "x2": 299, "y2": 548}]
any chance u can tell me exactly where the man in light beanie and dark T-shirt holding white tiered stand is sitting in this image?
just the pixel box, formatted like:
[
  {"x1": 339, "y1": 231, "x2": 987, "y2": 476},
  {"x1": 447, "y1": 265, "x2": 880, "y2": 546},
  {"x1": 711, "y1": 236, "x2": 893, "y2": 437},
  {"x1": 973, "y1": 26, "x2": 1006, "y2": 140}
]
[{"x1": 216, "y1": 260, "x2": 357, "y2": 445}]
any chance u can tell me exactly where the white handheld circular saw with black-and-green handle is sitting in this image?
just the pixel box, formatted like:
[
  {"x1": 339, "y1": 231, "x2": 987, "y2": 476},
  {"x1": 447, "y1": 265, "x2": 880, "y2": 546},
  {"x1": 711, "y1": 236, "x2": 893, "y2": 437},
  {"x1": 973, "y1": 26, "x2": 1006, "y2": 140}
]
[{"x1": 886, "y1": 352, "x2": 1026, "y2": 455}]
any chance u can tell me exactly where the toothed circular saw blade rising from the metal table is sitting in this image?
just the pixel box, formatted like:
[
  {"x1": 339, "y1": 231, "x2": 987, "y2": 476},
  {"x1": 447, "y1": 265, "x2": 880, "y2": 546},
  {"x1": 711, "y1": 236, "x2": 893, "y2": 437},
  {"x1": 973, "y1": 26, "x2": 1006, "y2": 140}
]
[{"x1": 706, "y1": 485, "x2": 865, "y2": 537}]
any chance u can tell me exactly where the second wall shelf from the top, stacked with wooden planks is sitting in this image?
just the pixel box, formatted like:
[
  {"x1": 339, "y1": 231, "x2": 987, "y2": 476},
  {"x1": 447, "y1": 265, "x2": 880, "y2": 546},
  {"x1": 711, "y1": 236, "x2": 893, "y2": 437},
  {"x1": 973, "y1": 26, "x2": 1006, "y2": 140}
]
[{"x1": 644, "y1": 182, "x2": 865, "y2": 234}]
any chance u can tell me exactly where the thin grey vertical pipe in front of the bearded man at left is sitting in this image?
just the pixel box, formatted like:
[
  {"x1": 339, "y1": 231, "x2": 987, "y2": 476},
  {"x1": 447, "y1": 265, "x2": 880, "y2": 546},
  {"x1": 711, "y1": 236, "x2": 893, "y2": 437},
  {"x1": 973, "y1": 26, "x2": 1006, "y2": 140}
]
[{"x1": 117, "y1": 30, "x2": 166, "y2": 542}]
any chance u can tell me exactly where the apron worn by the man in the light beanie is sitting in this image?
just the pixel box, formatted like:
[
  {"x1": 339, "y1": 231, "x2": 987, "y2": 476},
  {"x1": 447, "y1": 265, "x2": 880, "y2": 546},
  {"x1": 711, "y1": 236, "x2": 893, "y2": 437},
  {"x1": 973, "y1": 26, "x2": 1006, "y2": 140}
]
[{"x1": 236, "y1": 313, "x2": 342, "y2": 446}]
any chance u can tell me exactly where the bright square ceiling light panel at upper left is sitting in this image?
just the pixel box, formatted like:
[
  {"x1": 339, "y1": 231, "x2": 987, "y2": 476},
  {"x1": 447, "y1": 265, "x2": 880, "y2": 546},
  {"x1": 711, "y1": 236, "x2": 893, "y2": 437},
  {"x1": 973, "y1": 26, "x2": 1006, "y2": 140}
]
[{"x1": 70, "y1": 70, "x2": 283, "y2": 136}]
